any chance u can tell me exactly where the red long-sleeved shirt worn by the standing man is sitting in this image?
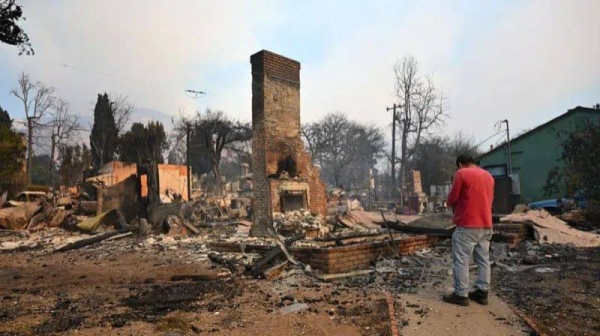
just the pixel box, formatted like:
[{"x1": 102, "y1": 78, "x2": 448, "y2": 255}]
[{"x1": 446, "y1": 166, "x2": 494, "y2": 229}]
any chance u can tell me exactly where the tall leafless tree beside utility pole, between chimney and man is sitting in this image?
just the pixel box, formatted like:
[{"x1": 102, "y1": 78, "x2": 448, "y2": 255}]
[{"x1": 393, "y1": 57, "x2": 446, "y2": 204}]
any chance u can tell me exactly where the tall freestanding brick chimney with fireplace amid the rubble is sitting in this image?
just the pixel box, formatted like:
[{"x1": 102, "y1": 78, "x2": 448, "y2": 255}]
[{"x1": 250, "y1": 50, "x2": 327, "y2": 236}]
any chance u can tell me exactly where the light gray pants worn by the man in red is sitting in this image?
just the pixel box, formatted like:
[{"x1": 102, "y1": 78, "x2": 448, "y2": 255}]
[{"x1": 452, "y1": 227, "x2": 492, "y2": 297}]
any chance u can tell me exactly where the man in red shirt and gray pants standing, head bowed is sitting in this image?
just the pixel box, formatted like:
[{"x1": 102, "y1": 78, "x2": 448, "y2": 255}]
[{"x1": 443, "y1": 155, "x2": 494, "y2": 306}]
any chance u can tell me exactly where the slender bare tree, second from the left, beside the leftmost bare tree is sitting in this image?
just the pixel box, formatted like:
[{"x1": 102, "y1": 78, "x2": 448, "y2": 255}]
[{"x1": 48, "y1": 99, "x2": 81, "y2": 185}]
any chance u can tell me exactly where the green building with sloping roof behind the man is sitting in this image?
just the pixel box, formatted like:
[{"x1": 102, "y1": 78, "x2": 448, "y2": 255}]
[{"x1": 477, "y1": 105, "x2": 600, "y2": 208}]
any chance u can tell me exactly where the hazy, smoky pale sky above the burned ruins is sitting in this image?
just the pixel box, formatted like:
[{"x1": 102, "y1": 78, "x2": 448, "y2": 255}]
[{"x1": 0, "y1": 0, "x2": 600, "y2": 150}]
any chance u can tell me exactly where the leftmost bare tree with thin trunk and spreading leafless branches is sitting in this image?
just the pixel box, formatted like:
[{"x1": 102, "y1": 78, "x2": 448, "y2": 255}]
[{"x1": 11, "y1": 72, "x2": 54, "y2": 185}]
